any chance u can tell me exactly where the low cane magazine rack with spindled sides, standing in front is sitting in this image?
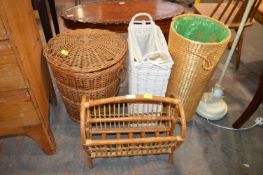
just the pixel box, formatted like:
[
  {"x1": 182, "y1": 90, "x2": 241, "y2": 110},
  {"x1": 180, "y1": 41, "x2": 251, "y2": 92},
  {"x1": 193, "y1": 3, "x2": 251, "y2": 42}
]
[{"x1": 80, "y1": 95, "x2": 186, "y2": 168}]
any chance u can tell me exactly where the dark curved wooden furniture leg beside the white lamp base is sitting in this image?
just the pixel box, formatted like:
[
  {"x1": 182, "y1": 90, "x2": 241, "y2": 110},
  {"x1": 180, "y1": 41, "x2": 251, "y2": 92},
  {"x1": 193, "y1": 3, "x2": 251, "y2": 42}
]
[{"x1": 232, "y1": 72, "x2": 263, "y2": 129}]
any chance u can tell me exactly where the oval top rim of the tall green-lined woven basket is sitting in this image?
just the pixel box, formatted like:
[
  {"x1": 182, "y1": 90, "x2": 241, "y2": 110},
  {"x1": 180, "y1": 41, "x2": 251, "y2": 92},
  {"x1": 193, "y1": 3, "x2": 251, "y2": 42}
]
[{"x1": 170, "y1": 14, "x2": 231, "y2": 45}]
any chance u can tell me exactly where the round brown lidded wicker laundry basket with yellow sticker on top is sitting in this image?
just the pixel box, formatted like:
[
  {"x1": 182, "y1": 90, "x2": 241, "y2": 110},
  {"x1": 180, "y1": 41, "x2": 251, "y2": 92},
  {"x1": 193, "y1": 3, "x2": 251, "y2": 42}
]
[{"x1": 44, "y1": 29, "x2": 127, "y2": 121}]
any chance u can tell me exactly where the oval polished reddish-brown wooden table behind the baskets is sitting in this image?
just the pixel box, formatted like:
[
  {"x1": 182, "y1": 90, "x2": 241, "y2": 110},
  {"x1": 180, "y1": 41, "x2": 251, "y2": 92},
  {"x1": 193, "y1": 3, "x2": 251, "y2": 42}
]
[{"x1": 61, "y1": 0, "x2": 184, "y2": 35}]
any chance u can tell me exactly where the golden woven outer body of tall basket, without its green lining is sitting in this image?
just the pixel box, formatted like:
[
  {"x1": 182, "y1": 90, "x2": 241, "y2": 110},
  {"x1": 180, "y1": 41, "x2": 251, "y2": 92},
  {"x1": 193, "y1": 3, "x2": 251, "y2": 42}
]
[{"x1": 166, "y1": 14, "x2": 231, "y2": 121}]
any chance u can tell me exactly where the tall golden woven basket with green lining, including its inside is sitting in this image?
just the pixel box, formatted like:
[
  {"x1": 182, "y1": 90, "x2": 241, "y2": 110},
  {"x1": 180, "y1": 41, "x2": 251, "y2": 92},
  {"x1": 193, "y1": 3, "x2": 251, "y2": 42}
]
[{"x1": 166, "y1": 14, "x2": 231, "y2": 121}]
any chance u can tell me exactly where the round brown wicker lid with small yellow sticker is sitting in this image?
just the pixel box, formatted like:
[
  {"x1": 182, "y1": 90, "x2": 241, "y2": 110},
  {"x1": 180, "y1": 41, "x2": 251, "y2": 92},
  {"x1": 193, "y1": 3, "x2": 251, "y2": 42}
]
[{"x1": 44, "y1": 29, "x2": 127, "y2": 72}]
